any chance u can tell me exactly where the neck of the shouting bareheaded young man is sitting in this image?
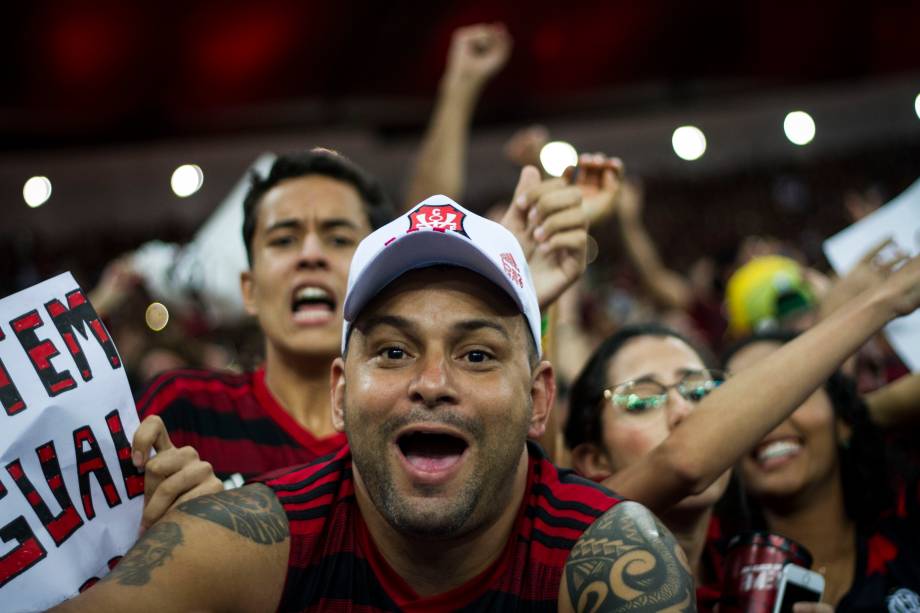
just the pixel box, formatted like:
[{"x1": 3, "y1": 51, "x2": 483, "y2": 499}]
[{"x1": 265, "y1": 345, "x2": 335, "y2": 437}]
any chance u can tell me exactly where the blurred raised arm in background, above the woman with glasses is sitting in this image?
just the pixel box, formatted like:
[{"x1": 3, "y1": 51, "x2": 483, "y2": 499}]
[{"x1": 617, "y1": 183, "x2": 693, "y2": 310}]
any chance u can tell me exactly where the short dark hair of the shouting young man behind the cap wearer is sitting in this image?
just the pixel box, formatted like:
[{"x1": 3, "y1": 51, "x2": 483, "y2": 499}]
[{"x1": 243, "y1": 148, "x2": 395, "y2": 265}]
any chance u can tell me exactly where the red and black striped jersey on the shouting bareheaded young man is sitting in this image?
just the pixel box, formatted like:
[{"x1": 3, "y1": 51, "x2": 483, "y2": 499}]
[{"x1": 137, "y1": 369, "x2": 346, "y2": 480}]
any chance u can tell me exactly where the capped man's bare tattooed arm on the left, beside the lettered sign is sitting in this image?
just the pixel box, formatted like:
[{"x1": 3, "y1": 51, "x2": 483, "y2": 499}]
[{"x1": 53, "y1": 485, "x2": 289, "y2": 612}]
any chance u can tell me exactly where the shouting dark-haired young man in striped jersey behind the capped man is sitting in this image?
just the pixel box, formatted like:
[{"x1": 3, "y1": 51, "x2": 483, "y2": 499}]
[{"x1": 137, "y1": 149, "x2": 393, "y2": 482}]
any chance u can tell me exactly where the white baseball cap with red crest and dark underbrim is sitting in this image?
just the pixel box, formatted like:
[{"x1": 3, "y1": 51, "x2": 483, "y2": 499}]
[{"x1": 342, "y1": 196, "x2": 542, "y2": 355}]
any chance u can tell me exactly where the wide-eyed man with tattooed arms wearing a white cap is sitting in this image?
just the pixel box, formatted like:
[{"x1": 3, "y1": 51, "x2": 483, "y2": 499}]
[{"x1": 54, "y1": 196, "x2": 694, "y2": 611}]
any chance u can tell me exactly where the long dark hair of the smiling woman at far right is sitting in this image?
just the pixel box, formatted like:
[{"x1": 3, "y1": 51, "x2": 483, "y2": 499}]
[{"x1": 720, "y1": 331, "x2": 893, "y2": 531}]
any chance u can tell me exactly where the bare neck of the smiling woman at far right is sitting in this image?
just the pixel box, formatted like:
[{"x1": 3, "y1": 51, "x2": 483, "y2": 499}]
[{"x1": 763, "y1": 470, "x2": 856, "y2": 567}]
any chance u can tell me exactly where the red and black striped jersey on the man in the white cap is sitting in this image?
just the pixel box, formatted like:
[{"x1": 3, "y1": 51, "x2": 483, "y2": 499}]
[{"x1": 266, "y1": 442, "x2": 619, "y2": 613}]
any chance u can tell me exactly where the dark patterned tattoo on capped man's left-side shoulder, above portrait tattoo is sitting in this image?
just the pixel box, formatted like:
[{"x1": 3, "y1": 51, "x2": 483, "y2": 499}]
[{"x1": 177, "y1": 484, "x2": 288, "y2": 545}]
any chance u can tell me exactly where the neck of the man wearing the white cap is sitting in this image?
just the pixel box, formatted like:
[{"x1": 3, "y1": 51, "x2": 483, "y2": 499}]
[{"x1": 355, "y1": 449, "x2": 528, "y2": 597}]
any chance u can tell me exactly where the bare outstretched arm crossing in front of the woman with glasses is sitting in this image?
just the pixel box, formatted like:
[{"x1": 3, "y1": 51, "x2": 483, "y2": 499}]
[{"x1": 605, "y1": 252, "x2": 920, "y2": 513}]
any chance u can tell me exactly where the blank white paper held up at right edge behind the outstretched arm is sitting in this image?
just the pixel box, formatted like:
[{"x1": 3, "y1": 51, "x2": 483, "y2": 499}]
[{"x1": 824, "y1": 175, "x2": 920, "y2": 372}]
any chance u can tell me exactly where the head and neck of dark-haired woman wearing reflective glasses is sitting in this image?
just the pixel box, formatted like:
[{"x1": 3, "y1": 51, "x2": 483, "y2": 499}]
[{"x1": 565, "y1": 324, "x2": 731, "y2": 605}]
